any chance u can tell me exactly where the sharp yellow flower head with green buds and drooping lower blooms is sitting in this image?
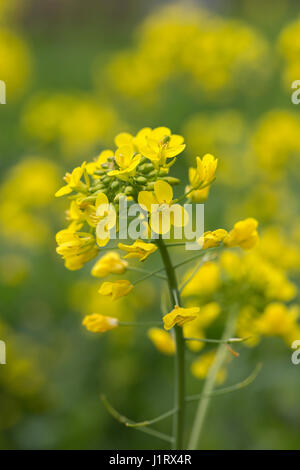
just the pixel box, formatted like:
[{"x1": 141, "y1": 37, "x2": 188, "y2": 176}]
[{"x1": 56, "y1": 127, "x2": 264, "y2": 354}]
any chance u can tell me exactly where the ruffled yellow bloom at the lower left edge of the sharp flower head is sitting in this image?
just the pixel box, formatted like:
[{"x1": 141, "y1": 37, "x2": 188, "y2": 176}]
[{"x1": 56, "y1": 225, "x2": 99, "y2": 271}]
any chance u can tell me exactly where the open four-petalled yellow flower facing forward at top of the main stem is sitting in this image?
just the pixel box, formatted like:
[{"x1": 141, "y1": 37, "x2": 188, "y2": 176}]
[{"x1": 138, "y1": 180, "x2": 188, "y2": 234}]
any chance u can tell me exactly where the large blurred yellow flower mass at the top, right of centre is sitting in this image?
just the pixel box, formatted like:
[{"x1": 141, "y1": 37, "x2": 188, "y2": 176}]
[{"x1": 103, "y1": 5, "x2": 268, "y2": 102}]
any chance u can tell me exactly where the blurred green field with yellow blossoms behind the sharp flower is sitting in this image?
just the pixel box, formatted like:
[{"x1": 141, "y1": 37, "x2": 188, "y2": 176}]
[{"x1": 0, "y1": 0, "x2": 300, "y2": 449}]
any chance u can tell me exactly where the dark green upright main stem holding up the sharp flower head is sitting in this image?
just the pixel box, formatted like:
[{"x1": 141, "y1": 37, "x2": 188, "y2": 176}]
[{"x1": 157, "y1": 237, "x2": 185, "y2": 449}]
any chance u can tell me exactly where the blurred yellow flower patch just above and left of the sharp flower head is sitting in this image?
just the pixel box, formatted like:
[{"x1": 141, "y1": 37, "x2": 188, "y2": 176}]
[{"x1": 22, "y1": 92, "x2": 117, "y2": 158}]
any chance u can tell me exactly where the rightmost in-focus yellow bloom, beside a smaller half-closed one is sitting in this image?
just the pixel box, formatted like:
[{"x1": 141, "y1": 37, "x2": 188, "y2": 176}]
[{"x1": 223, "y1": 218, "x2": 258, "y2": 250}]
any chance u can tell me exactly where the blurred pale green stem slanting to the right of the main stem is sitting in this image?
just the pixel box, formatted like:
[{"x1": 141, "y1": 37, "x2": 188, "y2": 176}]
[{"x1": 188, "y1": 309, "x2": 236, "y2": 450}]
